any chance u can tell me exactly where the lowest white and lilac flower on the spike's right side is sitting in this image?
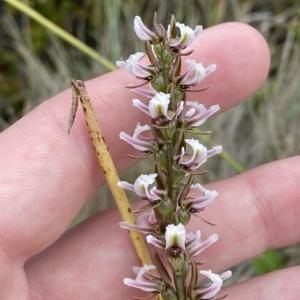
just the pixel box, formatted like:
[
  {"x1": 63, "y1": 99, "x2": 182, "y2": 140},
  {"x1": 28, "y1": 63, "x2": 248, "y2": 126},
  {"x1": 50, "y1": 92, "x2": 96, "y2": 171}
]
[{"x1": 193, "y1": 270, "x2": 232, "y2": 299}]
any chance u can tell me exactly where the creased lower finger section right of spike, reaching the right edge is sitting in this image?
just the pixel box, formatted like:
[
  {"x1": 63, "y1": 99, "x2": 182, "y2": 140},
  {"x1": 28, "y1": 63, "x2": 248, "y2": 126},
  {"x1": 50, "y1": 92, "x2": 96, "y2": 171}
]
[{"x1": 194, "y1": 156, "x2": 300, "y2": 271}]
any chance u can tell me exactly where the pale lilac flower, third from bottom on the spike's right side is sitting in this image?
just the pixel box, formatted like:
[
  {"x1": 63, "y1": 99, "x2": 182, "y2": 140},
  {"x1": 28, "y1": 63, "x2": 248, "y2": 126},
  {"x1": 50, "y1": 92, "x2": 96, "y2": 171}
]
[{"x1": 181, "y1": 183, "x2": 218, "y2": 213}]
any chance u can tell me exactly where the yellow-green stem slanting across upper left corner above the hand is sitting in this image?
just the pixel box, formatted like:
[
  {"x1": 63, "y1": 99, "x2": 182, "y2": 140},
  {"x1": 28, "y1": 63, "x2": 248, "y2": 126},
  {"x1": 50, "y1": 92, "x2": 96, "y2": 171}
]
[{"x1": 4, "y1": 0, "x2": 116, "y2": 71}]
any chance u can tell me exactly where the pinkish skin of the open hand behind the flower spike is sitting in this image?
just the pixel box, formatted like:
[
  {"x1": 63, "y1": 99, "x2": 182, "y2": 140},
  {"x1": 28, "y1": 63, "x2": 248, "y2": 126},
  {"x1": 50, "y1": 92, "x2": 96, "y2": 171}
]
[{"x1": 0, "y1": 23, "x2": 300, "y2": 300}]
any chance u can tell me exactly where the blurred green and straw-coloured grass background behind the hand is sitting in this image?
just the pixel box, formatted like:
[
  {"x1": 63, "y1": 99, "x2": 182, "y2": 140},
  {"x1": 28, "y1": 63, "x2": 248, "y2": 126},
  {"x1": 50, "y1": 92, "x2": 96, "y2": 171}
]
[{"x1": 0, "y1": 0, "x2": 300, "y2": 281}]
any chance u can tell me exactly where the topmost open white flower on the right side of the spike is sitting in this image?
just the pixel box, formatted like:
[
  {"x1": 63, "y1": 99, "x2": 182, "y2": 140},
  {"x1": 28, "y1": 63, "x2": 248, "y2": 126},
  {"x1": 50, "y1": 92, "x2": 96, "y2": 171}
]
[{"x1": 167, "y1": 22, "x2": 202, "y2": 51}]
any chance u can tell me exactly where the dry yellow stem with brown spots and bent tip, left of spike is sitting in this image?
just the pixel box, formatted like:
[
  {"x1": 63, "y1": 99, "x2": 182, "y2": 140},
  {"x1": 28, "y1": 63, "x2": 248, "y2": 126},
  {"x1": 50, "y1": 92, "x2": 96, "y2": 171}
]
[{"x1": 68, "y1": 80, "x2": 160, "y2": 299}]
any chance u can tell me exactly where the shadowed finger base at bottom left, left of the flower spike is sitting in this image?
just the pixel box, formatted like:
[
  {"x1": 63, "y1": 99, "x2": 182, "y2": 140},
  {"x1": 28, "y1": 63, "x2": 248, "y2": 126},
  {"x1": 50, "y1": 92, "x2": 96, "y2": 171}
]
[{"x1": 25, "y1": 211, "x2": 142, "y2": 300}]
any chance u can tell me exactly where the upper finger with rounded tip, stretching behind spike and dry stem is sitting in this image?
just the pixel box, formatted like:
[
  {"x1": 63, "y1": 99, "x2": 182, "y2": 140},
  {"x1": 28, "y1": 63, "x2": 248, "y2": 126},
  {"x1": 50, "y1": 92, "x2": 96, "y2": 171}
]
[{"x1": 0, "y1": 23, "x2": 269, "y2": 257}]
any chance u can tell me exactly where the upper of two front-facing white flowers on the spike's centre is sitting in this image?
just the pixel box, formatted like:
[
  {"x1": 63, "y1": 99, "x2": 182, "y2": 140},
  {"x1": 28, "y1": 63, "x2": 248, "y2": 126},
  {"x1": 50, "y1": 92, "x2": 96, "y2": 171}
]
[{"x1": 132, "y1": 92, "x2": 183, "y2": 123}]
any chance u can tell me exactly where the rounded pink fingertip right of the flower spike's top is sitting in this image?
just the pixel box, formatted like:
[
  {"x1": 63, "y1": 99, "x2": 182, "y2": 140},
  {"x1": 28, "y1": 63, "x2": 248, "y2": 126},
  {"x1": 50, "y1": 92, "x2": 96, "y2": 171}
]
[{"x1": 191, "y1": 22, "x2": 270, "y2": 110}]
